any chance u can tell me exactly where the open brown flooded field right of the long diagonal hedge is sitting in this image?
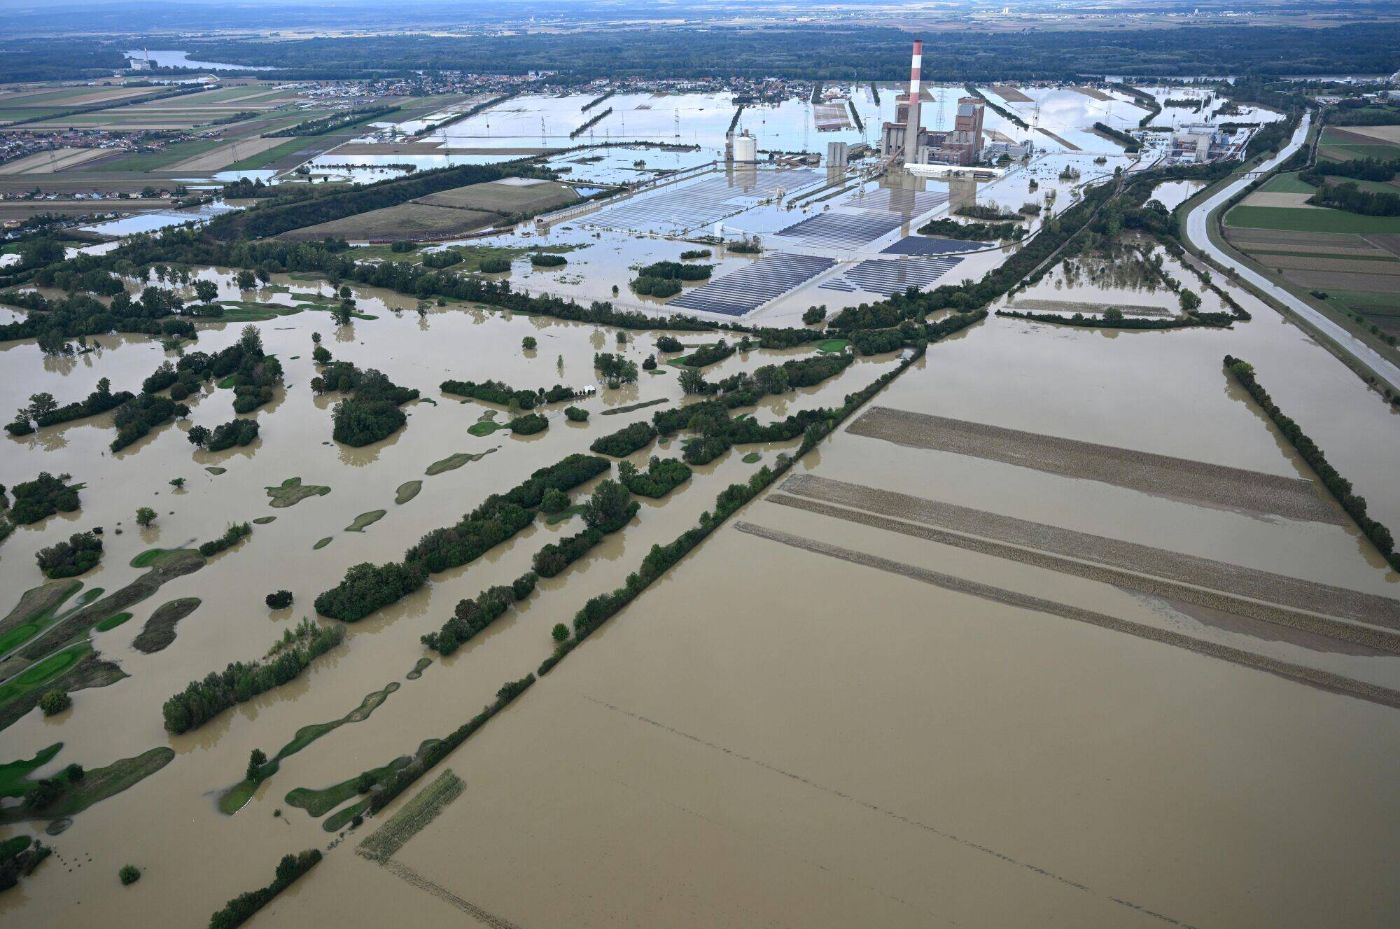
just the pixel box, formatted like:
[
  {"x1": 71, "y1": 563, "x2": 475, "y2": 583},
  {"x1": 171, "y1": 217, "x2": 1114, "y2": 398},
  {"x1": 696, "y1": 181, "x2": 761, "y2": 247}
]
[{"x1": 257, "y1": 275, "x2": 1400, "y2": 926}]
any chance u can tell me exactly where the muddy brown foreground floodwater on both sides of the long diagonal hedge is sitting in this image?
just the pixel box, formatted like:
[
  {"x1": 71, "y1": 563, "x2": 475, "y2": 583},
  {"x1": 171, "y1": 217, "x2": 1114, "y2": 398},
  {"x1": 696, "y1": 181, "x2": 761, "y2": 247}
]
[{"x1": 0, "y1": 240, "x2": 1400, "y2": 929}]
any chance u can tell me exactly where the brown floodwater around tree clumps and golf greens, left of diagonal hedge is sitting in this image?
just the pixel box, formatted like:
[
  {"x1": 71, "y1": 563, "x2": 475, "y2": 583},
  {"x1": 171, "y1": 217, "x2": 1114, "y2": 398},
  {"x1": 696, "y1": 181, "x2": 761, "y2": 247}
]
[{"x1": 0, "y1": 264, "x2": 892, "y2": 926}]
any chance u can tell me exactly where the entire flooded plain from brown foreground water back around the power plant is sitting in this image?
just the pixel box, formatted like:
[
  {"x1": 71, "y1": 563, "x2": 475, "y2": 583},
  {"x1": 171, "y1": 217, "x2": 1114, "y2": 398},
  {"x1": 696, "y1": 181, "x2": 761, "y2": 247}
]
[{"x1": 0, "y1": 70, "x2": 1400, "y2": 929}]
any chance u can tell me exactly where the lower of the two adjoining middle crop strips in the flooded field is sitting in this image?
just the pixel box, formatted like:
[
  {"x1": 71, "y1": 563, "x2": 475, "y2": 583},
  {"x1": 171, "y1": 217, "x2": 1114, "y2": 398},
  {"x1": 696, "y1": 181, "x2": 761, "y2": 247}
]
[{"x1": 770, "y1": 494, "x2": 1400, "y2": 655}]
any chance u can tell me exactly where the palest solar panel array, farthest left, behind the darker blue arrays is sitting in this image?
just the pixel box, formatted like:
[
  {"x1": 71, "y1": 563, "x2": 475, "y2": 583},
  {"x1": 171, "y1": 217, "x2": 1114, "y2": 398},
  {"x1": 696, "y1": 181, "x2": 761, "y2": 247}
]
[{"x1": 585, "y1": 168, "x2": 826, "y2": 235}]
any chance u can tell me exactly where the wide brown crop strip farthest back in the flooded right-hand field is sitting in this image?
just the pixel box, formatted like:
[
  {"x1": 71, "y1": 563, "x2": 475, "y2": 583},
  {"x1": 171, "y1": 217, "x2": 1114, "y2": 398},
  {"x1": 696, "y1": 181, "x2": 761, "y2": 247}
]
[{"x1": 847, "y1": 407, "x2": 1347, "y2": 526}]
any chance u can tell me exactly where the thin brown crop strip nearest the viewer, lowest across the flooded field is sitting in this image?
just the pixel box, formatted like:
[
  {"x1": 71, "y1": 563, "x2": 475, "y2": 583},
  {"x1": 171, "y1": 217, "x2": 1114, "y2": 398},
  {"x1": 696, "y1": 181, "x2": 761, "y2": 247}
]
[{"x1": 735, "y1": 522, "x2": 1400, "y2": 709}]
